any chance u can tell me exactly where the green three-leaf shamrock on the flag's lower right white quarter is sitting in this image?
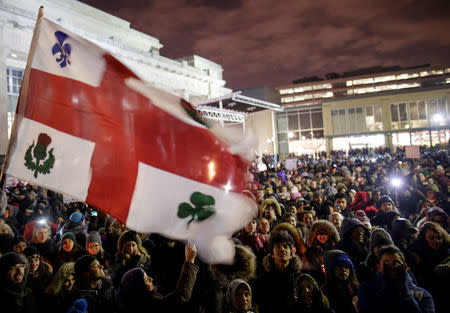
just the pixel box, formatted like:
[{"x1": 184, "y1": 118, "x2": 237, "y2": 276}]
[{"x1": 178, "y1": 192, "x2": 216, "y2": 226}]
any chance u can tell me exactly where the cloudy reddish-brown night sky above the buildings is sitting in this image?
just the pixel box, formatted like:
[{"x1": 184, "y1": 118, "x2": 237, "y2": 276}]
[{"x1": 81, "y1": 0, "x2": 450, "y2": 89}]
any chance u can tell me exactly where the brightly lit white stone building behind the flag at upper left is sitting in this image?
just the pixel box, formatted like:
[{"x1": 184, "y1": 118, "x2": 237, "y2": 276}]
[{"x1": 0, "y1": 0, "x2": 231, "y2": 155}]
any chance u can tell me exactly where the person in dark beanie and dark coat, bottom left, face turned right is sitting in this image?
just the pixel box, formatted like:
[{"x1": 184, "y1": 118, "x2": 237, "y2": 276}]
[{"x1": 61, "y1": 254, "x2": 116, "y2": 313}]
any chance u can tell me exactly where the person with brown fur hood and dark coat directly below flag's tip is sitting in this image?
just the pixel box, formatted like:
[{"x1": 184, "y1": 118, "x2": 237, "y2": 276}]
[{"x1": 199, "y1": 245, "x2": 257, "y2": 313}]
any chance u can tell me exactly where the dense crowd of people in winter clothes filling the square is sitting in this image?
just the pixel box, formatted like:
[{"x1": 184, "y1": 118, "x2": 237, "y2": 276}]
[{"x1": 0, "y1": 145, "x2": 450, "y2": 313}]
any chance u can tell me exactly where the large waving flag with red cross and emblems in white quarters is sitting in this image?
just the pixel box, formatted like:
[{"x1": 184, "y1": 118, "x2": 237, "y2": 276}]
[{"x1": 6, "y1": 17, "x2": 255, "y2": 263}]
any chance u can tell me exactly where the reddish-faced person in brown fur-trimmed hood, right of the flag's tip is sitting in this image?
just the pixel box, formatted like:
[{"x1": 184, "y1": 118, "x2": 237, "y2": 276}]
[{"x1": 303, "y1": 220, "x2": 340, "y2": 284}]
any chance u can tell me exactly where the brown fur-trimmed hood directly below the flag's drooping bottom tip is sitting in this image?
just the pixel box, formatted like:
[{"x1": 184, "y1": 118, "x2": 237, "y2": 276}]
[{"x1": 208, "y1": 245, "x2": 256, "y2": 285}]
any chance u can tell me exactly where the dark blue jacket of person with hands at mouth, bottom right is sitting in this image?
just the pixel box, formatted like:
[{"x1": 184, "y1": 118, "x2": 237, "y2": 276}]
[{"x1": 358, "y1": 272, "x2": 434, "y2": 313}]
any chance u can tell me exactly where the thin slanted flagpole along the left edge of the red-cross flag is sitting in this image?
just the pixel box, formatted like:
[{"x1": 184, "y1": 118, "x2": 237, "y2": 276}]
[{"x1": 0, "y1": 5, "x2": 44, "y2": 189}]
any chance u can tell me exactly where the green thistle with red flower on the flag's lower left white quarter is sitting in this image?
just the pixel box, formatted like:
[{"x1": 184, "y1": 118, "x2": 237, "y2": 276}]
[{"x1": 25, "y1": 133, "x2": 55, "y2": 178}]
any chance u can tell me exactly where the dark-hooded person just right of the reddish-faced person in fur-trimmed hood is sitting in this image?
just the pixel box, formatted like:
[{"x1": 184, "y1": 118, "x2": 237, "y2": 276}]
[{"x1": 336, "y1": 218, "x2": 370, "y2": 266}]
